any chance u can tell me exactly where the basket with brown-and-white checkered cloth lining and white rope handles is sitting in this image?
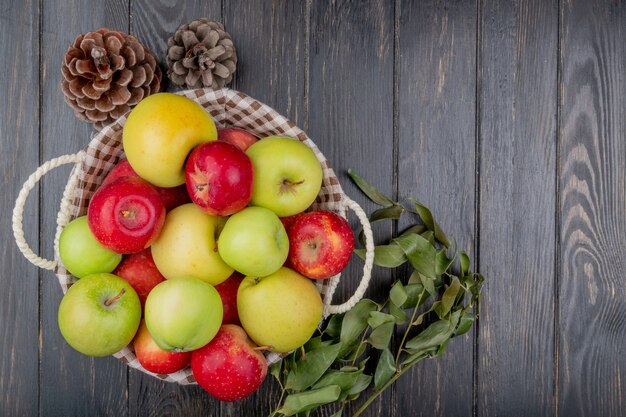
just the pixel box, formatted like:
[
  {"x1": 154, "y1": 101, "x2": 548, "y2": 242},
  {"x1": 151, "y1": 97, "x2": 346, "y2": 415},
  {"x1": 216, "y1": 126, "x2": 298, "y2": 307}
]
[{"x1": 13, "y1": 88, "x2": 373, "y2": 384}]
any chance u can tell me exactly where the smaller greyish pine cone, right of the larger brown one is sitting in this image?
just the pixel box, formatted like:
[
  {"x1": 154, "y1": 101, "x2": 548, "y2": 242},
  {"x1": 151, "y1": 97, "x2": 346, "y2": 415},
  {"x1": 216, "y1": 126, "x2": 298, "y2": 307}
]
[{"x1": 167, "y1": 19, "x2": 237, "y2": 88}]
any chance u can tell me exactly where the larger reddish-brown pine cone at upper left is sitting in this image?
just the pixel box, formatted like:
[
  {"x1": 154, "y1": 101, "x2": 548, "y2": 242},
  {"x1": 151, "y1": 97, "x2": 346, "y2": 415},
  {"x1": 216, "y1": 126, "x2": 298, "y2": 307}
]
[{"x1": 61, "y1": 28, "x2": 161, "y2": 130}]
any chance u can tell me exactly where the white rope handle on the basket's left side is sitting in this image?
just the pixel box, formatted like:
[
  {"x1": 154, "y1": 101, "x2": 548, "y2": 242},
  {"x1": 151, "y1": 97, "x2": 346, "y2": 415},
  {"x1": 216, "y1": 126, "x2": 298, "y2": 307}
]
[{"x1": 12, "y1": 151, "x2": 85, "y2": 270}]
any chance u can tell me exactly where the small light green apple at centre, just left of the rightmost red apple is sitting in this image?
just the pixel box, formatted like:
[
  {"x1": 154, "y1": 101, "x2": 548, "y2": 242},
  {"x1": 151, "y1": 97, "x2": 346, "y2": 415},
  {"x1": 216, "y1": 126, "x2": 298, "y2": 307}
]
[{"x1": 217, "y1": 207, "x2": 289, "y2": 277}]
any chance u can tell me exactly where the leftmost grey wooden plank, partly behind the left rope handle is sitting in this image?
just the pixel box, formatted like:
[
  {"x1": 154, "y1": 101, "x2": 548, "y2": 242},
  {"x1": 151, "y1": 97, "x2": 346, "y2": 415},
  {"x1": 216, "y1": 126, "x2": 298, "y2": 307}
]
[{"x1": 0, "y1": 1, "x2": 40, "y2": 416}]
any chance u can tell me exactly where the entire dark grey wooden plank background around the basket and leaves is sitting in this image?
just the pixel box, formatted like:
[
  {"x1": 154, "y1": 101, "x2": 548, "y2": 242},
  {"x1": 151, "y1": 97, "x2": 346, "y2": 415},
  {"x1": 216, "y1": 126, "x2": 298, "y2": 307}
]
[{"x1": 0, "y1": 0, "x2": 626, "y2": 417}]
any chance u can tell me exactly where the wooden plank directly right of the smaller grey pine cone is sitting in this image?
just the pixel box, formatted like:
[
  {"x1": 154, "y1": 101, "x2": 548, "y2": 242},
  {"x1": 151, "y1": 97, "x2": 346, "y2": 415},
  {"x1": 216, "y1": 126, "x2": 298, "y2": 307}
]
[{"x1": 222, "y1": 0, "x2": 308, "y2": 416}]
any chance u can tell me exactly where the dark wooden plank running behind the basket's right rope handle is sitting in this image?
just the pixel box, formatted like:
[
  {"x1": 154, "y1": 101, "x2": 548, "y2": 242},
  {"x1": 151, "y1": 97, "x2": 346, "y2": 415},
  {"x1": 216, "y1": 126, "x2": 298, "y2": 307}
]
[{"x1": 308, "y1": 0, "x2": 395, "y2": 416}]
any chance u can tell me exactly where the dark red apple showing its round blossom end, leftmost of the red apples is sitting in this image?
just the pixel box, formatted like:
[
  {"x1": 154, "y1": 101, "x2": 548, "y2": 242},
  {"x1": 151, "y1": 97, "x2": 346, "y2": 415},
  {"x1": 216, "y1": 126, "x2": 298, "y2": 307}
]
[{"x1": 87, "y1": 177, "x2": 165, "y2": 254}]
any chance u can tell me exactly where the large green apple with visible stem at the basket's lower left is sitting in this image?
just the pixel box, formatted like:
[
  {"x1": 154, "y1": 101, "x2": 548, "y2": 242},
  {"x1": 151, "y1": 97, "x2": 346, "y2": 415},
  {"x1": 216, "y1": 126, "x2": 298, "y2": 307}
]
[{"x1": 58, "y1": 273, "x2": 141, "y2": 356}]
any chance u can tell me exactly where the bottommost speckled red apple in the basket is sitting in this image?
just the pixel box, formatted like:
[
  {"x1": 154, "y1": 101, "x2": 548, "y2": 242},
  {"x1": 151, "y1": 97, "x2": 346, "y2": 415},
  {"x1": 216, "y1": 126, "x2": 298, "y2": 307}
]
[{"x1": 191, "y1": 324, "x2": 267, "y2": 401}]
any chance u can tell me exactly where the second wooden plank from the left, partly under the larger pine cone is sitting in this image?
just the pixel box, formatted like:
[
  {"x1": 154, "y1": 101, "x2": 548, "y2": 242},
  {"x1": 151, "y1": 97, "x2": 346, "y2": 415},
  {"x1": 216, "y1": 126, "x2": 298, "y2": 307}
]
[{"x1": 40, "y1": 0, "x2": 128, "y2": 416}]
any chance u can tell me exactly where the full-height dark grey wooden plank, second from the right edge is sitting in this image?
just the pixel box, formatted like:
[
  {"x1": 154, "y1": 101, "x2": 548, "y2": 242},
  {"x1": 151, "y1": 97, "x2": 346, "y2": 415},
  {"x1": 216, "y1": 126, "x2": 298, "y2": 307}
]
[{"x1": 476, "y1": 0, "x2": 558, "y2": 416}]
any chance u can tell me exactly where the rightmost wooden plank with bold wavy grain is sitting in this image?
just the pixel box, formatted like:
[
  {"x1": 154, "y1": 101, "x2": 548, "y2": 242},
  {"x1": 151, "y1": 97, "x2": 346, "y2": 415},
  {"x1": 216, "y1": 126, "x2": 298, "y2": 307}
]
[{"x1": 558, "y1": 1, "x2": 626, "y2": 416}]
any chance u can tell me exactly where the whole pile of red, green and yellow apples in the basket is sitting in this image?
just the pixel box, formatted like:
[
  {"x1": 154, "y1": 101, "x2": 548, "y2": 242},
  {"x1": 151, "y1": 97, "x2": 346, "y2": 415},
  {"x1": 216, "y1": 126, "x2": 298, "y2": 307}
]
[{"x1": 58, "y1": 93, "x2": 354, "y2": 401}]
